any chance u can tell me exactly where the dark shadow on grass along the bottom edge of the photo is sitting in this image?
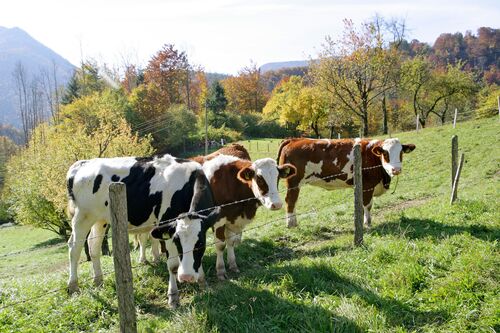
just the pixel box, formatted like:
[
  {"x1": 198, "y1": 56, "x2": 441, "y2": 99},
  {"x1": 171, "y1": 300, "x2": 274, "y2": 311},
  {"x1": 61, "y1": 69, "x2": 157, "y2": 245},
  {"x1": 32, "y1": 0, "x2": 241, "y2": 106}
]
[{"x1": 193, "y1": 281, "x2": 362, "y2": 332}]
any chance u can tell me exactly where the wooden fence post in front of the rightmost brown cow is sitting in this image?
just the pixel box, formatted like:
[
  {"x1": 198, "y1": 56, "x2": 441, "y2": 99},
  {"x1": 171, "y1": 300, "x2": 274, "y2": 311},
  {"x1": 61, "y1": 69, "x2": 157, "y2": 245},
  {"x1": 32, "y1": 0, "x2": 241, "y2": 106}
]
[{"x1": 354, "y1": 143, "x2": 363, "y2": 245}]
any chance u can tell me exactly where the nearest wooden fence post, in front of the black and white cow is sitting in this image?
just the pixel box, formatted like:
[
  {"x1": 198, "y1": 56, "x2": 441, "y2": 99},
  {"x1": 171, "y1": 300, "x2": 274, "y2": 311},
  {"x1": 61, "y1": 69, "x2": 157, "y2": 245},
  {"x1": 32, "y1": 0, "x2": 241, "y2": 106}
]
[{"x1": 109, "y1": 183, "x2": 137, "y2": 333}]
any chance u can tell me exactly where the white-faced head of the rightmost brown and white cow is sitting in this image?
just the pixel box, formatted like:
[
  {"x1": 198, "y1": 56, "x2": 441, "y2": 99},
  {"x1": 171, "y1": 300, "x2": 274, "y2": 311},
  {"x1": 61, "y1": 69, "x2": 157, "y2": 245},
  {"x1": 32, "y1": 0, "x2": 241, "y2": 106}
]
[{"x1": 372, "y1": 139, "x2": 415, "y2": 177}]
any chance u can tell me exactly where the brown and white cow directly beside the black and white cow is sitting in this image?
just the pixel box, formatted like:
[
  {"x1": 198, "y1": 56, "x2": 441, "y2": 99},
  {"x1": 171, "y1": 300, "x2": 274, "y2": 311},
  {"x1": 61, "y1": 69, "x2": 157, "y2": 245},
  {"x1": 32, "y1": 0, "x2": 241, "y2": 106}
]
[{"x1": 190, "y1": 144, "x2": 295, "y2": 280}]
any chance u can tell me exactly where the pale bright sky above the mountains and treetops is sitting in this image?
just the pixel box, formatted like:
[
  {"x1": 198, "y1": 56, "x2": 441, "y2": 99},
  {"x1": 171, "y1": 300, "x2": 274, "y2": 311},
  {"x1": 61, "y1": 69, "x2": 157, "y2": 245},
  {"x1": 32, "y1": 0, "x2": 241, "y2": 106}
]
[{"x1": 0, "y1": 0, "x2": 500, "y2": 74}]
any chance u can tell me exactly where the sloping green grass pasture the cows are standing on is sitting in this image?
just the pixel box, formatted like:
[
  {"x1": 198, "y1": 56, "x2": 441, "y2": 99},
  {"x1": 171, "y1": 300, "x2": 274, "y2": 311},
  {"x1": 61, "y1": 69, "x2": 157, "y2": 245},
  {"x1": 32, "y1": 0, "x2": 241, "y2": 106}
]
[{"x1": 0, "y1": 119, "x2": 500, "y2": 332}]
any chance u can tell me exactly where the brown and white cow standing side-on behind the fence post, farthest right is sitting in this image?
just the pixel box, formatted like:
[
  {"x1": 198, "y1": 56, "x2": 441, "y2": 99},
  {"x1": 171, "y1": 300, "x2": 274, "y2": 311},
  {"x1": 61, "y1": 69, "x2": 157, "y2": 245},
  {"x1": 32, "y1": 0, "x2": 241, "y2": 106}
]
[{"x1": 278, "y1": 138, "x2": 415, "y2": 227}]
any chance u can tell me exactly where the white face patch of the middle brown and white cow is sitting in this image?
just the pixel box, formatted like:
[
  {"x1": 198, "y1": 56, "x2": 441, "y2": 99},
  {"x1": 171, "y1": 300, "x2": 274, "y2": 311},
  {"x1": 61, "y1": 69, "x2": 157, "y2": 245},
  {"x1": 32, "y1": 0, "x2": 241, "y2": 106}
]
[{"x1": 252, "y1": 158, "x2": 283, "y2": 209}]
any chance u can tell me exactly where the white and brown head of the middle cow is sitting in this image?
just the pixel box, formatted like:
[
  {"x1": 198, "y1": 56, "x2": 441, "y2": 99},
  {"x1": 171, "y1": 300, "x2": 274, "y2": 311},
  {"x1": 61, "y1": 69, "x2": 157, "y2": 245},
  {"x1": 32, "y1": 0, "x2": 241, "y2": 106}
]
[{"x1": 238, "y1": 158, "x2": 297, "y2": 210}]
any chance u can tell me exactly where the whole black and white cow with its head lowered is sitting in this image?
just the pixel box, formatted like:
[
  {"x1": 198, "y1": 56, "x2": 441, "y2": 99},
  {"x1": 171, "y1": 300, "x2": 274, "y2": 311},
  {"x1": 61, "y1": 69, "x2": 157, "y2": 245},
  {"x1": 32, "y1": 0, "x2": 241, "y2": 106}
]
[{"x1": 67, "y1": 155, "x2": 218, "y2": 306}]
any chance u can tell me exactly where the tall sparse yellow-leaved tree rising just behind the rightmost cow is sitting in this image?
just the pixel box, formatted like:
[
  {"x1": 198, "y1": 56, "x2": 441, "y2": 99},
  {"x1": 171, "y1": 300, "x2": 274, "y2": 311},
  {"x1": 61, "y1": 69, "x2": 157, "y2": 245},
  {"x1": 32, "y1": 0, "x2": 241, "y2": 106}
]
[{"x1": 311, "y1": 20, "x2": 398, "y2": 136}]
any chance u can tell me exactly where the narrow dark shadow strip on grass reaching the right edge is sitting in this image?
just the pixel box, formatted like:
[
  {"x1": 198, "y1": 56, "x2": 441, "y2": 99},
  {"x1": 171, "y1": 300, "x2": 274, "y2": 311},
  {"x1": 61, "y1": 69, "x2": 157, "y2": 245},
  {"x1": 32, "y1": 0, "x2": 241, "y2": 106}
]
[{"x1": 370, "y1": 216, "x2": 500, "y2": 241}]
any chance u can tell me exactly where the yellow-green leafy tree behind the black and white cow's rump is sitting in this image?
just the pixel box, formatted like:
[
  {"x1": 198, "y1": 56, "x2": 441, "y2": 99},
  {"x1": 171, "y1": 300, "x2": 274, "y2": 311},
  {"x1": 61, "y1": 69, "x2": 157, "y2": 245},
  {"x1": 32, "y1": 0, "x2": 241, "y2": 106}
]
[{"x1": 3, "y1": 91, "x2": 153, "y2": 239}]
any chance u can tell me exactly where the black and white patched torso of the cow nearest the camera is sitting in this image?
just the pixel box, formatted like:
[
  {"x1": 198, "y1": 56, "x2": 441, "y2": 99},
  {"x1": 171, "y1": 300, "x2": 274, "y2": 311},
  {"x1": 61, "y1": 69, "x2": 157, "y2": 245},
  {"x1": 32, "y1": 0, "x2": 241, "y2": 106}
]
[{"x1": 68, "y1": 155, "x2": 202, "y2": 226}]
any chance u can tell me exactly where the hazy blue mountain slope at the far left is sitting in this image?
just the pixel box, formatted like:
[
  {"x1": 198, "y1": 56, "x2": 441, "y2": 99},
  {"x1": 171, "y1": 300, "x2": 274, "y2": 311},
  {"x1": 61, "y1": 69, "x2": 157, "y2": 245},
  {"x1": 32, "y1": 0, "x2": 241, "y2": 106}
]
[{"x1": 0, "y1": 27, "x2": 75, "y2": 127}]
